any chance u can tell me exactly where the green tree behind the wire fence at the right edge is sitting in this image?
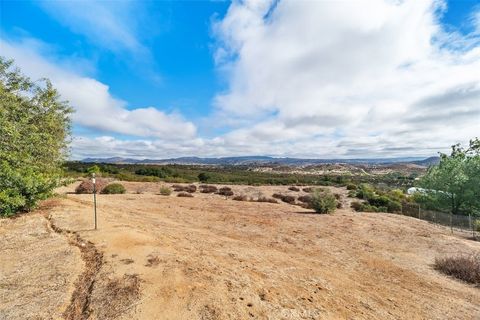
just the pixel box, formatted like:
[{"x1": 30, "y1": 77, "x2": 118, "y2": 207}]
[{"x1": 419, "y1": 138, "x2": 480, "y2": 215}]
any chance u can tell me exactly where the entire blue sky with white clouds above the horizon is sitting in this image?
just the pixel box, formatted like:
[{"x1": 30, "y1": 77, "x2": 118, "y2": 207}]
[{"x1": 0, "y1": 0, "x2": 480, "y2": 159}]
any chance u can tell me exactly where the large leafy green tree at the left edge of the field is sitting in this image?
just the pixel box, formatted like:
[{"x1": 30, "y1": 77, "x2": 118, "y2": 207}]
[{"x1": 0, "y1": 57, "x2": 72, "y2": 216}]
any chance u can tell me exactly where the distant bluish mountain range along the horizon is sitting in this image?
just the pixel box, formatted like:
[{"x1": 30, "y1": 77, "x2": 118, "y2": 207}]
[{"x1": 81, "y1": 156, "x2": 440, "y2": 167}]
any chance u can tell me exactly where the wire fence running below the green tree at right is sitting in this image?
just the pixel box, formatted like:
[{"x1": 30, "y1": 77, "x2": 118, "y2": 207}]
[{"x1": 401, "y1": 203, "x2": 480, "y2": 238}]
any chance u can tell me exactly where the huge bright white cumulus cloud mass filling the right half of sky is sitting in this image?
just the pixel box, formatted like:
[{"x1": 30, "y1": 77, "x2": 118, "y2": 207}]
[{"x1": 214, "y1": 0, "x2": 480, "y2": 156}]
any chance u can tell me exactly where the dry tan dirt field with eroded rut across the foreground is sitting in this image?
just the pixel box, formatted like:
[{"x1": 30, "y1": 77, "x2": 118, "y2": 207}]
[{"x1": 0, "y1": 183, "x2": 480, "y2": 319}]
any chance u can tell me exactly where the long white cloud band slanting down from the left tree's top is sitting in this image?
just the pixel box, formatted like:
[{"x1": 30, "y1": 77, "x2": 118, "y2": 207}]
[{"x1": 0, "y1": 40, "x2": 196, "y2": 140}]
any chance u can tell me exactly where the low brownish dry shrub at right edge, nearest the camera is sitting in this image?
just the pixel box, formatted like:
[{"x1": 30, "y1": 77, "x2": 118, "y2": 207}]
[{"x1": 434, "y1": 254, "x2": 480, "y2": 286}]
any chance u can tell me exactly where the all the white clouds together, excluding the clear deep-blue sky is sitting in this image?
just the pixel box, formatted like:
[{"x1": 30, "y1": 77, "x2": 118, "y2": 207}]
[{"x1": 1, "y1": 0, "x2": 480, "y2": 158}]
